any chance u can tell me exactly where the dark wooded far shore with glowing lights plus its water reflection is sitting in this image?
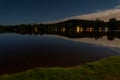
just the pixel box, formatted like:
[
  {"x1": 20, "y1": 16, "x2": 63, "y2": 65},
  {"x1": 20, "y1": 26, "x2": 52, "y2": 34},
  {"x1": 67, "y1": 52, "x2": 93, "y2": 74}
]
[{"x1": 0, "y1": 18, "x2": 120, "y2": 40}]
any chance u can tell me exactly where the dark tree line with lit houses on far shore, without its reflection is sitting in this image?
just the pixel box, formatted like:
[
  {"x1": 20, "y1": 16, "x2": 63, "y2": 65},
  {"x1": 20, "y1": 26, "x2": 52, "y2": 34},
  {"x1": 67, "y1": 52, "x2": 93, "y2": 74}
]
[{"x1": 0, "y1": 18, "x2": 120, "y2": 33}]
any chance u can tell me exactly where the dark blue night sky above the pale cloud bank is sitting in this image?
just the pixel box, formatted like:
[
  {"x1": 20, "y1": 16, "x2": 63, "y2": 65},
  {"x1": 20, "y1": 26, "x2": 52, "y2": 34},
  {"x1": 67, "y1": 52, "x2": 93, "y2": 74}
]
[{"x1": 0, "y1": 0, "x2": 120, "y2": 25}]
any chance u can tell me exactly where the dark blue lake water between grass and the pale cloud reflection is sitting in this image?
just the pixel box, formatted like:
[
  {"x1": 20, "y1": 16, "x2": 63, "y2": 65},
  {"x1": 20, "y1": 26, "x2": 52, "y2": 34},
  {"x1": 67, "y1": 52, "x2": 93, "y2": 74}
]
[{"x1": 0, "y1": 33, "x2": 119, "y2": 74}]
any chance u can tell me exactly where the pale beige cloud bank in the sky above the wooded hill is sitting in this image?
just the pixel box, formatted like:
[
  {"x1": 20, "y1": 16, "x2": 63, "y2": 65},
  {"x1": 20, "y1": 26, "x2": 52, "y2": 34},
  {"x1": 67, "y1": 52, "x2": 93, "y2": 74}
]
[{"x1": 45, "y1": 5, "x2": 120, "y2": 23}]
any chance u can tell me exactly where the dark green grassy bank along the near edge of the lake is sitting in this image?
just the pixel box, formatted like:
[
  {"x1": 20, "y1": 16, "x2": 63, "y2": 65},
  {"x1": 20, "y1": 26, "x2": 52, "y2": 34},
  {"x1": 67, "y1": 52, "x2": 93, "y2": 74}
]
[{"x1": 0, "y1": 56, "x2": 120, "y2": 80}]
